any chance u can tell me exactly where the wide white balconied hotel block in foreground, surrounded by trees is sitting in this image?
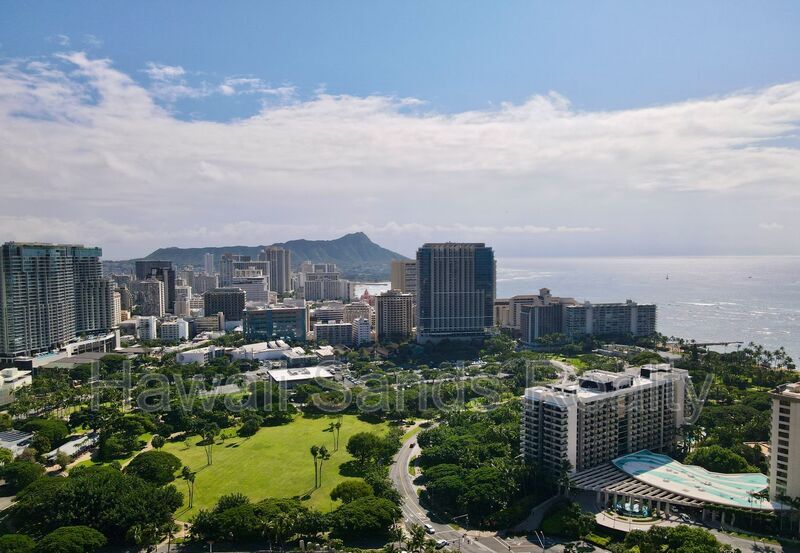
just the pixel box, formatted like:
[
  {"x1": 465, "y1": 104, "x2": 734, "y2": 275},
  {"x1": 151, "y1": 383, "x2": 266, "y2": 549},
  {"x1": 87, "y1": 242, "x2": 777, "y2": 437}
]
[{"x1": 521, "y1": 364, "x2": 689, "y2": 473}]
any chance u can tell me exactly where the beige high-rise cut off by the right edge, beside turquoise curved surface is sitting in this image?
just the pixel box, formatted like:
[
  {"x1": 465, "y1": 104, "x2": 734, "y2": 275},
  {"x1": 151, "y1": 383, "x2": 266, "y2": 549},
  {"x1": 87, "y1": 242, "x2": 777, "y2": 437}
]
[{"x1": 769, "y1": 382, "x2": 800, "y2": 501}]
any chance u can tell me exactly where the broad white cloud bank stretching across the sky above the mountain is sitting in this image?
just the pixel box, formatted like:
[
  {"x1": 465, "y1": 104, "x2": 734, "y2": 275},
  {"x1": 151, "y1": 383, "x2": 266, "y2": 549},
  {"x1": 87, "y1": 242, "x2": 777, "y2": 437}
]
[{"x1": 0, "y1": 52, "x2": 800, "y2": 256}]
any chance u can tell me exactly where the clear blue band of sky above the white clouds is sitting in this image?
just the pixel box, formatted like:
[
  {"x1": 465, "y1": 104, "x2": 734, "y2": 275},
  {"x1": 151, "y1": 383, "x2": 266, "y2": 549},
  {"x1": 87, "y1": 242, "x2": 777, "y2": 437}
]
[{"x1": 0, "y1": 0, "x2": 800, "y2": 119}]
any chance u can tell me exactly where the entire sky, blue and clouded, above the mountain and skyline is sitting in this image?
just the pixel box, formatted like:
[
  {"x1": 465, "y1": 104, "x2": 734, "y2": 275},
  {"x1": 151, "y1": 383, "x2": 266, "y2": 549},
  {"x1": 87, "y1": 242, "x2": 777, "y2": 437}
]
[{"x1": 0, "y1": 0, "x2": 800, "y2": 259}]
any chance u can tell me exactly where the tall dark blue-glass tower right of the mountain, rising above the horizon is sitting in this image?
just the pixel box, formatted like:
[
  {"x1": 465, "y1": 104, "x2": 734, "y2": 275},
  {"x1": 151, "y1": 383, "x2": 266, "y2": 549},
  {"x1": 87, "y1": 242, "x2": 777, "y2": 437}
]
[{"x1": 417, "y1": 242, "x2": 495, "y2": 342}]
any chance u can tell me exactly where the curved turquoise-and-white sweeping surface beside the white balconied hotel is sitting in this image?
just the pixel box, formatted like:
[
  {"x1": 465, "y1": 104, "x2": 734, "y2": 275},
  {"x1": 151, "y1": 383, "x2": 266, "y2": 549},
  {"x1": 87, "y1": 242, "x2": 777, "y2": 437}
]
[{"x1": 613, "y1": 450, "x2": 781, "y2": 510}]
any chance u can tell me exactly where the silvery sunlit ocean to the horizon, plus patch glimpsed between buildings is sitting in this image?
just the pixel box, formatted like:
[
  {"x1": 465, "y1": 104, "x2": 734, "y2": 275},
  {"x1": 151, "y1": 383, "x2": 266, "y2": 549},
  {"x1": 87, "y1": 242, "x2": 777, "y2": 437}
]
[{"x1": 357, "y1": 256, "x2": 800, "y2": 362}]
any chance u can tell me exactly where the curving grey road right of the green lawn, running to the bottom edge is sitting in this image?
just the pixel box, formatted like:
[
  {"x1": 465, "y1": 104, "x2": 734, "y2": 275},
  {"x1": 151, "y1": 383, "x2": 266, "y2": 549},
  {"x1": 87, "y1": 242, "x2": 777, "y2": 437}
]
[{"x1": 389, "y1": 435, "x2": 580, "y2": 553}]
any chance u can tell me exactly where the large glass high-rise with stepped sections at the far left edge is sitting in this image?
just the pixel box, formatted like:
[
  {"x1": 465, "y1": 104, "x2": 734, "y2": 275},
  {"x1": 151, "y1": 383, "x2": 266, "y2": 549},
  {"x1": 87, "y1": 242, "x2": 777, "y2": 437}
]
[{"x1": 0, "y1": 242, "x2": 114, "y2": 359}]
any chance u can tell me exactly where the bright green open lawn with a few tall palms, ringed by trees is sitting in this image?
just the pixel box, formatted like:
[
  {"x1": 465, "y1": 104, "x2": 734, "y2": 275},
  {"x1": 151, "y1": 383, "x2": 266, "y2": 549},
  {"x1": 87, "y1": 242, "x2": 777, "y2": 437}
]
[{"x1": 162, "y1": 415, "x2": 388, "y2": 520}]
